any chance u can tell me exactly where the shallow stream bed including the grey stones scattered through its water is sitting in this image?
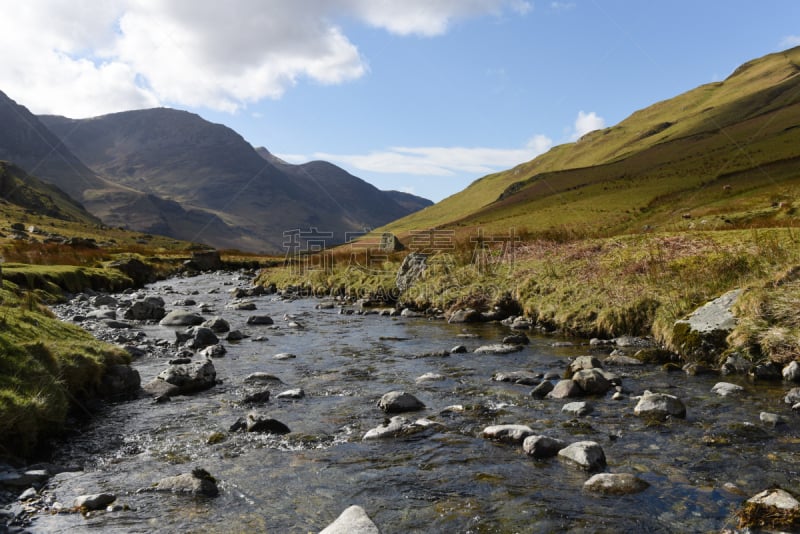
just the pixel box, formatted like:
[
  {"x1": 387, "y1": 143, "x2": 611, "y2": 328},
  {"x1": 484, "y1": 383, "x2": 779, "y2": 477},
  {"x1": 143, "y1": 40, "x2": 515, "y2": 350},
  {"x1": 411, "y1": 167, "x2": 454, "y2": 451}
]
[{"x1": 0, "y1": 272, "x2": 800, "y2": 533}]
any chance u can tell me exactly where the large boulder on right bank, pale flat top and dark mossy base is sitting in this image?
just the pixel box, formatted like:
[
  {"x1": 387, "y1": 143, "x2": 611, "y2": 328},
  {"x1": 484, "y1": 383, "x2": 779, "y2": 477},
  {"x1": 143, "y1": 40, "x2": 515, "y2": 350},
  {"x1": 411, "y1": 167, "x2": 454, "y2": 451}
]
[{"x1": 672, "y1": 289, "x2": 742, "y2": 364}]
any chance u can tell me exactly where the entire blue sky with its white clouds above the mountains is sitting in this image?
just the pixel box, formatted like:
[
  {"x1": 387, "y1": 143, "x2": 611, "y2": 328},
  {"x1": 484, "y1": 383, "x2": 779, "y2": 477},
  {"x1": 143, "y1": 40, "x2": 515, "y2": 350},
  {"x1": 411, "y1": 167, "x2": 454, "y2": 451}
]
[{"x1": 0, "y1": 0, "x2": 800, "y2": 201}]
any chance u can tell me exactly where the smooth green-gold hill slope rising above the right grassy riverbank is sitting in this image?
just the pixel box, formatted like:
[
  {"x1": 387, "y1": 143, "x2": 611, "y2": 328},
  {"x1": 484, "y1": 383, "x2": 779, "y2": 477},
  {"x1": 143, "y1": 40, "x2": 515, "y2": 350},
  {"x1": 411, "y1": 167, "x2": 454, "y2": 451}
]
[{"x1": 384, "y1": 47, "x2": 800, "y2": 241}]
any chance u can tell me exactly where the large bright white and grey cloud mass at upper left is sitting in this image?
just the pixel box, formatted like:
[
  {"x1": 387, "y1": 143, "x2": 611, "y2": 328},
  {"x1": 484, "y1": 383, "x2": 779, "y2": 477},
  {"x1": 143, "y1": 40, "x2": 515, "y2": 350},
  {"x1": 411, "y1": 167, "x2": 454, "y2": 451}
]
[{"x1": 0, "y1": 0, "x2": 531, "y2": 117}]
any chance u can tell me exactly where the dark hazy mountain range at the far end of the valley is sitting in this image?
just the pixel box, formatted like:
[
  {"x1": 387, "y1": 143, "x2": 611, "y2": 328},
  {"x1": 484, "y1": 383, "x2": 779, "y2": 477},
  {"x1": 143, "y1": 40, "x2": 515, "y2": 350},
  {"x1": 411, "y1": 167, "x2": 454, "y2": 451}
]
[{"x1": 39, "y1": 108, "x2": 432, "y2": 251}]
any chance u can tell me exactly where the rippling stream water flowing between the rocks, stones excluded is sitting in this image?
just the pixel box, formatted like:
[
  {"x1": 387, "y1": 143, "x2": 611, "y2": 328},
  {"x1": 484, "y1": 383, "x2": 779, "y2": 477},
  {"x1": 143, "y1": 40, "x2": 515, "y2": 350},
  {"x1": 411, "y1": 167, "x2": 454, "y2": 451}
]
[{"x1": 25, "y1": 273, "x2": 800, "y2": 534}]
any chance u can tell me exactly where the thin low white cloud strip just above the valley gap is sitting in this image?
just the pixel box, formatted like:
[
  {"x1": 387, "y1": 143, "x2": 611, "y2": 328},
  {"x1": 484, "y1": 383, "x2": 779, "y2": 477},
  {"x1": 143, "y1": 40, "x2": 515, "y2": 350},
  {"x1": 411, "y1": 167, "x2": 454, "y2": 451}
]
[{"x1": 310, "y1": 135, "x2": 553, "y2": 176}]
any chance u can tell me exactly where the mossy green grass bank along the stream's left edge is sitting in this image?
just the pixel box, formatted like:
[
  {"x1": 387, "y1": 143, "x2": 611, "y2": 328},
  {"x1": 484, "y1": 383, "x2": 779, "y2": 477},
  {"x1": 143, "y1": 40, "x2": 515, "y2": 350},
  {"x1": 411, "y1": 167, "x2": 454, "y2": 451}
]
[{"x1": 0, "y1": 253, "x2": 268, "y2": 463}]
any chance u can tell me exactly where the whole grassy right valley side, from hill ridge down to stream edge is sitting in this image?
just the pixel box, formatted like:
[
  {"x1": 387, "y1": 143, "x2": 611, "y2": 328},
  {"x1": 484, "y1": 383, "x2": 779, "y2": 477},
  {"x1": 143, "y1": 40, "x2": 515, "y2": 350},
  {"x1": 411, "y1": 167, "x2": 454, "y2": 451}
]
[{"x1": 261, "y1": 47, "x2": 800, "y2": 363}]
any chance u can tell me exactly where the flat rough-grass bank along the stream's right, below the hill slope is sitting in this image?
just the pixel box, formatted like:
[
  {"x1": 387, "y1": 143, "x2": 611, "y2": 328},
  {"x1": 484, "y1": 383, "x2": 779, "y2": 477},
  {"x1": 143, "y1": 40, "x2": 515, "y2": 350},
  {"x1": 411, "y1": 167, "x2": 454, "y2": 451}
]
[{"x1": 258, "y1": 228, "x2": 800, "y2": 365}]
